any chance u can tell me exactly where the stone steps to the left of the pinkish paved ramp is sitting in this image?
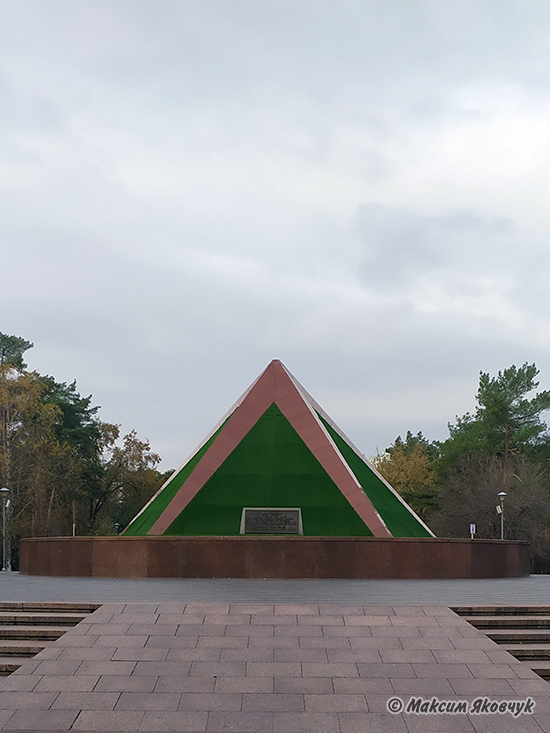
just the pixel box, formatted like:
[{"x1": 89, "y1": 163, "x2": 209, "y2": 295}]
[{"x1": 0, "y1": 603, "x2": 100, "y2": 677}]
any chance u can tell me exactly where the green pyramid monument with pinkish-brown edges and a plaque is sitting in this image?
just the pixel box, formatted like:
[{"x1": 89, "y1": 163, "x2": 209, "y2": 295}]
[{"x1": 123, "y1": 360, "x2": 434, "y2": 537}]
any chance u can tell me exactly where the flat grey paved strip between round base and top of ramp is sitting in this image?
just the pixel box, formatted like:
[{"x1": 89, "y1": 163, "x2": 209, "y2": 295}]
[{"x1": 0, "y1": 572, "x2": 550, "y2": 604}]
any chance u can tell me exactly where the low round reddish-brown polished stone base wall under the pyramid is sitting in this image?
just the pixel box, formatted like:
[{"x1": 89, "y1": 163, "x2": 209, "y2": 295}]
[{"x1": 20, "y1": 537, "x2": 530, "y2": 579}]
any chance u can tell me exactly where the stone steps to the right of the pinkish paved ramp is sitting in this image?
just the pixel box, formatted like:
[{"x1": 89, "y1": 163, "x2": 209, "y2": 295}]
[{"x1": 452, "y1": 605, "x2": 550, "y2": 682}]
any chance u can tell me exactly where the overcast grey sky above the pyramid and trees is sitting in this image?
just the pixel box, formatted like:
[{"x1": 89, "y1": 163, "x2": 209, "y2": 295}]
[{"x1": 0, "y1": 0, "x2": 550, "y2": 468}]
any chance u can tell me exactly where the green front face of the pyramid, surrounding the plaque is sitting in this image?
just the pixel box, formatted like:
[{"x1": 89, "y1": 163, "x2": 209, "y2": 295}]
[{"x1": 166, "y1": 404, "x2": 372, "y2": 536}]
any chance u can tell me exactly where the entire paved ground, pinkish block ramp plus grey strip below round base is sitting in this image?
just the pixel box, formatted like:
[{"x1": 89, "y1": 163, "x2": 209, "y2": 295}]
[{"x1": 0, "y1": 573, "x2": 550, "y2": 733}]
